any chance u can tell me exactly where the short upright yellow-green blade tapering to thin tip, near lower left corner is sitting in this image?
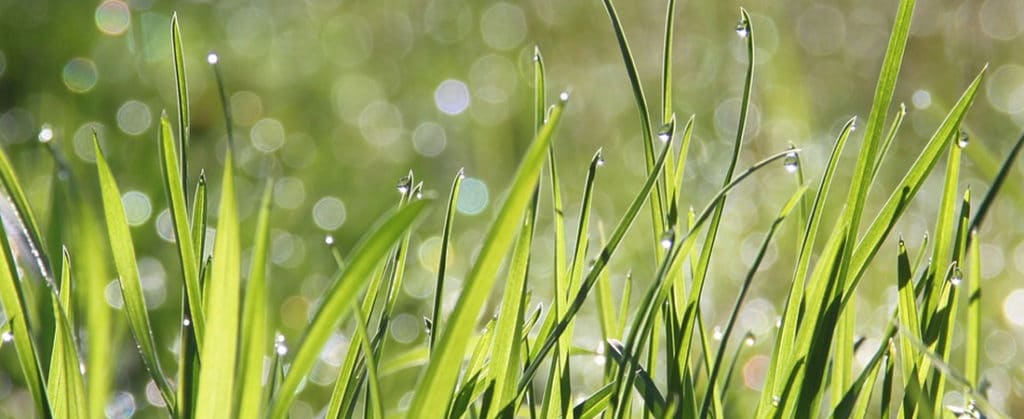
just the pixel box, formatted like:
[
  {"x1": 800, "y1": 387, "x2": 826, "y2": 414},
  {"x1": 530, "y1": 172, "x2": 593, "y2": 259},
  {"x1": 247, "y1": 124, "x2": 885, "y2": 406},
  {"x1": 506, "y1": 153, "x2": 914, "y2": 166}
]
[{"x1": 46, "y1": 249, "x2": 88, "y2": 419}]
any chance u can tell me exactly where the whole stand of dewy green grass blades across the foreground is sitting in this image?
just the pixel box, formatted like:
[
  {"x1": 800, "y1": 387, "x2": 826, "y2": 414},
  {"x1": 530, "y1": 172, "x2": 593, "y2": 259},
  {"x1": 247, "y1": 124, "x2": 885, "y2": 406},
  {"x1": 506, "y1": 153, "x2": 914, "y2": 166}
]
[{"x1": 0, "y1": 0, "x2": 1024, "y2": 418}]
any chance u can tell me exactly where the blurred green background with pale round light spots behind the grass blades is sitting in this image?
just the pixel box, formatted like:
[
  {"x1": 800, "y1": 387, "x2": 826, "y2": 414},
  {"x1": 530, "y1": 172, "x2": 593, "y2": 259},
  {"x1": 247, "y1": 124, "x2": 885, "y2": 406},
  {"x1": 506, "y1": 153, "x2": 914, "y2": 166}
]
[{"x1": 0, "y1": 0, "x2": 1024, "y2": 417}]
